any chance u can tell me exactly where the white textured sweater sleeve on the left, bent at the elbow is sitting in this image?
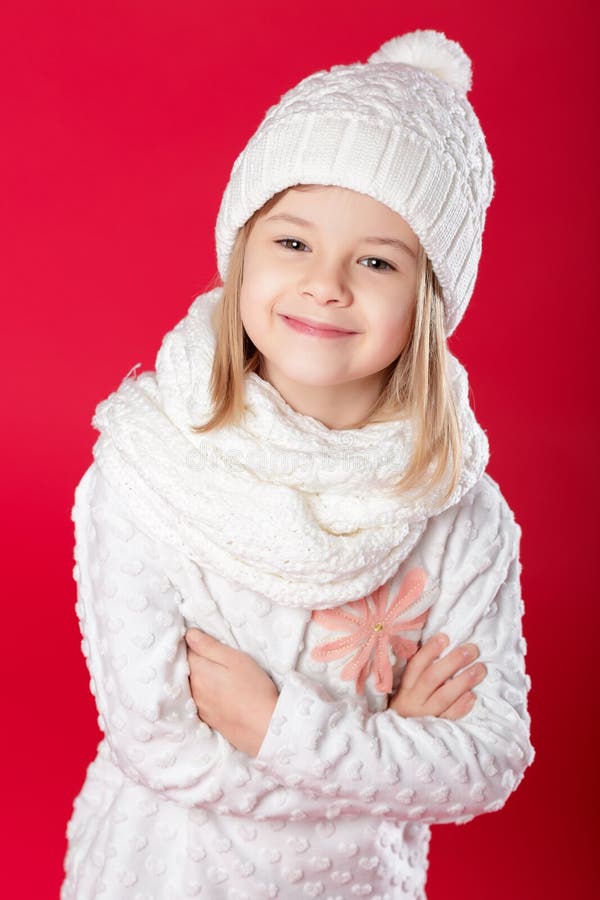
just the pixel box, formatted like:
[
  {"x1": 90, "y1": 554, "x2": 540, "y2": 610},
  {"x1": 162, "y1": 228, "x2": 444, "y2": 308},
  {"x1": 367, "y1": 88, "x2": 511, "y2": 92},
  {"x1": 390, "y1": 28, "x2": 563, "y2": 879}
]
[{"x1": 71, "y1": 463, "x2": 298, "y2": 817}]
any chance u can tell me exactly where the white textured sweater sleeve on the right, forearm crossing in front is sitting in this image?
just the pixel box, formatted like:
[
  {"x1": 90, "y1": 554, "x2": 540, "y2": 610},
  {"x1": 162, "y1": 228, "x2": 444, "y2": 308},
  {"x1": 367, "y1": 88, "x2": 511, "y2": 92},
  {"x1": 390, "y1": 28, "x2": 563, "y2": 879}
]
[{"x1": 254, "y1": 479, "x2": 535, "y2": 824}]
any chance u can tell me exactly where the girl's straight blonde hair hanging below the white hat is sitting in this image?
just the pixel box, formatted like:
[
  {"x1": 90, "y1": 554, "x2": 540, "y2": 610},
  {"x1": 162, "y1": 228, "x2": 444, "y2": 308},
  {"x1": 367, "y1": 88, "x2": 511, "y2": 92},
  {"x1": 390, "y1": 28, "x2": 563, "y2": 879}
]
[{"x1": 192, "y1": 185, "x2": 463, "y2": 502}]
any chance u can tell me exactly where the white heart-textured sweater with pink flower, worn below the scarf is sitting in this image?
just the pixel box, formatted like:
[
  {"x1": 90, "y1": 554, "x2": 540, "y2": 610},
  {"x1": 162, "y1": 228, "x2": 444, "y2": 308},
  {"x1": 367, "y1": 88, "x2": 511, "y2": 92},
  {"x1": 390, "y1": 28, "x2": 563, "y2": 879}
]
[{"x1": 60, "y1": 292, "x2": 534, "y2": 900}]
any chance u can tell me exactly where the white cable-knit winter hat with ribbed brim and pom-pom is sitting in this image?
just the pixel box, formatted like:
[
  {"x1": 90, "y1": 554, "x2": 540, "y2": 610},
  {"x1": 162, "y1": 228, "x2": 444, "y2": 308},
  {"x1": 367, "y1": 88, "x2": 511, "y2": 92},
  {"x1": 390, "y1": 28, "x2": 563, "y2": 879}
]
[{"x1": 215, "y1": 30, "x2": 494, "y2": 336}]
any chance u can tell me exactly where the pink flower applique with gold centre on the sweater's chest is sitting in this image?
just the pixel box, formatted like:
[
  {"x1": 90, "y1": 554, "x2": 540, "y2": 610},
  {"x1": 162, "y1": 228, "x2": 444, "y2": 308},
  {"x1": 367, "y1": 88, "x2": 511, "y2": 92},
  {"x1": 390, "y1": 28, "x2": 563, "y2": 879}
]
[{"x1": 311, "y1": 568, "x2": 429, "y2": 694}]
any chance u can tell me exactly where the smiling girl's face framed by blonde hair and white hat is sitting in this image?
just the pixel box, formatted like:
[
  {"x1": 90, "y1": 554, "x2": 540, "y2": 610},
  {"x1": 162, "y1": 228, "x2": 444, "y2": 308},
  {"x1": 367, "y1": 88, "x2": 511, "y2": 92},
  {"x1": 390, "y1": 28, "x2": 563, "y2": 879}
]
[{"x1": 240, "y1": 185, "x2": 419, "y2": 427}]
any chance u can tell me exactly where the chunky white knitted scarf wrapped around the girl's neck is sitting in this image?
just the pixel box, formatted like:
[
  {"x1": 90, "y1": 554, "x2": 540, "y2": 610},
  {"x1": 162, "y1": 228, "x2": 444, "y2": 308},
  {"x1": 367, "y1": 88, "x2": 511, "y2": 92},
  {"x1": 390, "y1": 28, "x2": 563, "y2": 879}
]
[{"x1": 92, "y1": 287, "x2": 489, "y2": 609}]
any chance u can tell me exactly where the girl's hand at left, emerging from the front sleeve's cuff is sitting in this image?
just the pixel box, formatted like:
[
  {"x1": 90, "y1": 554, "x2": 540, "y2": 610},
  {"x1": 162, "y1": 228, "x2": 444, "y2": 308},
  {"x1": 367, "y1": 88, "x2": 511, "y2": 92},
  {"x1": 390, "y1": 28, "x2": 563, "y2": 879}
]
[{"x1": 185, "y1": 628, "x2": 279, "y2": 756}]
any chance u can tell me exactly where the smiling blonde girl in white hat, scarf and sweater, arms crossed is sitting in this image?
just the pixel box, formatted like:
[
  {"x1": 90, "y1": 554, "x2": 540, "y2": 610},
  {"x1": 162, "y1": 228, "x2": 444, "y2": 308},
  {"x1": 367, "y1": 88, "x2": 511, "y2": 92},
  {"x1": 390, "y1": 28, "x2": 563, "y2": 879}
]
[{"x1": 61, "y1": 31, "x2": 534, "y2": 900}]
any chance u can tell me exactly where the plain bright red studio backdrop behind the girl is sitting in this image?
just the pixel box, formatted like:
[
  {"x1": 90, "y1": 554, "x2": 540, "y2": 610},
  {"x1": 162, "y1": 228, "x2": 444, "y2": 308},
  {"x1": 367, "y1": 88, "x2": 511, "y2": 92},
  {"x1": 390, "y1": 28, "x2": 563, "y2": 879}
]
[{"x1": 0, "y1": 0, "x2": 598, "y2": 900}]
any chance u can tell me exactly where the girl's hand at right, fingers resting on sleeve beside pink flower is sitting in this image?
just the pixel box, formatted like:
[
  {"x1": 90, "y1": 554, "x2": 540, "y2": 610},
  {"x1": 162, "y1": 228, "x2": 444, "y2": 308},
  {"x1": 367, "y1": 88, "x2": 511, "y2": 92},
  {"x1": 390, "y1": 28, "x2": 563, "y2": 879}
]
[{"x1": 388, "y1": 634, "x2": 487, "y2": 719}]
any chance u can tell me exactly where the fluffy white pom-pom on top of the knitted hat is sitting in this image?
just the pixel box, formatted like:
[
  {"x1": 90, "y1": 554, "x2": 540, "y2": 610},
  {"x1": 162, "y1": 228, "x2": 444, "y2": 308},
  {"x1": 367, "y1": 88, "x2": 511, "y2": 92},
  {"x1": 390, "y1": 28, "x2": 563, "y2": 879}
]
[{"x1": 367, "y1": 29, "x2": 473, "y2": 94}]
